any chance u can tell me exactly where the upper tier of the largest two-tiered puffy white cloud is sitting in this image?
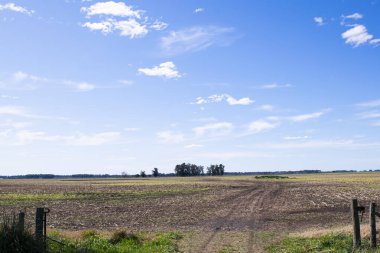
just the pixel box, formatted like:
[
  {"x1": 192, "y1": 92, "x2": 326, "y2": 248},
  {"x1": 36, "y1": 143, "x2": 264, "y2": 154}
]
[{"x1": 81, "y1": 1, "x2": 143, "y2": 19}]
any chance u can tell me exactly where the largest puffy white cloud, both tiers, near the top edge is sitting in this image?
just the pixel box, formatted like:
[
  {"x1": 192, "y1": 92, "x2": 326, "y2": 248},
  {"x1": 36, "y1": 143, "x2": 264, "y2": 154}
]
[{"x1": 81, "y1": 1, "x2": 168, "y2": 39}]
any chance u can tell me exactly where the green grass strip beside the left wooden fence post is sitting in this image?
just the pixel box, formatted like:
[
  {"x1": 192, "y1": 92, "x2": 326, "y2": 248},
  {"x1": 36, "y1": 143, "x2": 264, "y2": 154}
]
[{"x1": 49, "y1": 231, "x2": 181, "y2": 253}]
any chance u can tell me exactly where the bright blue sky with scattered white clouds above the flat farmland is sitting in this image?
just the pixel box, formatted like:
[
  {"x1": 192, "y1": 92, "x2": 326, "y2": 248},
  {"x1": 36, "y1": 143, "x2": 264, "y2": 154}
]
[{"x1": 0, "y1": 0, "x2": 380, "y2": 175}]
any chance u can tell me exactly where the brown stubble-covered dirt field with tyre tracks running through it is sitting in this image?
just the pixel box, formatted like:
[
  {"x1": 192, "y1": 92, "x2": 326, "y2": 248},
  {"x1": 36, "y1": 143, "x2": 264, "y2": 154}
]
[{"x1": 0, "y1": 173, "x2": 380, "y2": 252}]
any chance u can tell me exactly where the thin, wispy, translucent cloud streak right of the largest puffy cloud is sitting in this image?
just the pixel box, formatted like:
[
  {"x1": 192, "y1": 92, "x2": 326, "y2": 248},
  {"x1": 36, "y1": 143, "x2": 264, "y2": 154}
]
[{"x1": 161, "y1": 26, "x2": 234, "y2": 55}]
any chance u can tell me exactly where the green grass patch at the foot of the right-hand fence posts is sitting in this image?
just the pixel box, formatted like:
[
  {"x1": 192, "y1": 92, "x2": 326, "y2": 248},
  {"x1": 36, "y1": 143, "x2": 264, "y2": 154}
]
[{"x1": 266, "y1": 233, "x2": 380, "y2": 253}]
